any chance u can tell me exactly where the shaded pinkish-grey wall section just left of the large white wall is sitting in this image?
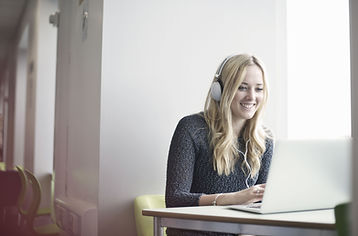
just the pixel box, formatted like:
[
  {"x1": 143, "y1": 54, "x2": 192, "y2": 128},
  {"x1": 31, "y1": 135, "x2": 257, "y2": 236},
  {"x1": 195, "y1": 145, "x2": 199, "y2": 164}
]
[{"x1": 54, "y1": 0, "x2": 102, "y2": 229}]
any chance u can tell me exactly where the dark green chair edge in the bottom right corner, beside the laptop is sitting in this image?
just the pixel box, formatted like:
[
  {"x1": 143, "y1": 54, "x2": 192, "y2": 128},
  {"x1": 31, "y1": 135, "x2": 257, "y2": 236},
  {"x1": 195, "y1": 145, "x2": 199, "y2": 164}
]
[{"x1": 334, "y1": 203, "x2": 351, "y2": 236}]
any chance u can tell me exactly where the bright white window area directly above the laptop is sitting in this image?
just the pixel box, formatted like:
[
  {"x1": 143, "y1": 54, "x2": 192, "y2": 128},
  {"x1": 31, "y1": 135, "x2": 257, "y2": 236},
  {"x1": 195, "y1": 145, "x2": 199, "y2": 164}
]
[{"x1": 287, "y1": 0, "x2": 351, "y2": 138}]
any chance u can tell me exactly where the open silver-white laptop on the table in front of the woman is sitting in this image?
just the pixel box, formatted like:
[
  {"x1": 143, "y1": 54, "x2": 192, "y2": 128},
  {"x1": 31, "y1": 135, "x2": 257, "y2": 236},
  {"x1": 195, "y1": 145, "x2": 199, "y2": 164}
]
[{"x1": 229, "y1": 138, "x2": 352, "y2": 214}]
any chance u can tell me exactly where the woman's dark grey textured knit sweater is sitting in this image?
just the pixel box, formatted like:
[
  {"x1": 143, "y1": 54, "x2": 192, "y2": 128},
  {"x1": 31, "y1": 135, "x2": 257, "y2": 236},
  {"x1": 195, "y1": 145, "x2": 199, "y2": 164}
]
[{"x1": 165, "y1": 113, "x2": 273, "y2": 235}]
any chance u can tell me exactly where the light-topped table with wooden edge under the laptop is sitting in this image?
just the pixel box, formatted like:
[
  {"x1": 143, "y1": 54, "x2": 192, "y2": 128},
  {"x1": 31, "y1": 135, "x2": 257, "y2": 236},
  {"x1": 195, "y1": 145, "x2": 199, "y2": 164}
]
[{"x1": 142, "y1": 206, "x2": 337, "y2": 236}]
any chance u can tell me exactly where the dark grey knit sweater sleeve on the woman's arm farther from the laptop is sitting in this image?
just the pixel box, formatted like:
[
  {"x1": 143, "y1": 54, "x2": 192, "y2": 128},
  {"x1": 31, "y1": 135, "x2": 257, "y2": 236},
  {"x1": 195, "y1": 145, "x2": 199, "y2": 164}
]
[{"x1": 165, "y1": 118, "x2": 202, "y2": 207}]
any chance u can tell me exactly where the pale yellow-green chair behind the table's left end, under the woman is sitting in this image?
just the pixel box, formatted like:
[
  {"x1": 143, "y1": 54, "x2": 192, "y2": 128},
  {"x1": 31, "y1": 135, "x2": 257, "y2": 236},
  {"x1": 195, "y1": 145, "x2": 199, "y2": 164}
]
[{"x1": 134, "y1": 195, "x2": 166, "y2": 236}]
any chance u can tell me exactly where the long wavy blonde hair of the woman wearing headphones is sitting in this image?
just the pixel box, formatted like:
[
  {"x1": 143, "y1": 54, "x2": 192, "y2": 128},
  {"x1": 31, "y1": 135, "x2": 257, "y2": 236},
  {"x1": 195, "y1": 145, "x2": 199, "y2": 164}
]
[{"x1": 204, "y1": 54, "x2": 270, "y2": 177}]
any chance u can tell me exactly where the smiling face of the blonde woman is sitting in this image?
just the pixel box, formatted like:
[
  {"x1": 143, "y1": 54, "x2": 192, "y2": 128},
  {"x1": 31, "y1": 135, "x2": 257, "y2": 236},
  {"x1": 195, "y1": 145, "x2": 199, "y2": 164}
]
[{"x1": 230, "y1": 65, "x2": 264, "y2": 123}]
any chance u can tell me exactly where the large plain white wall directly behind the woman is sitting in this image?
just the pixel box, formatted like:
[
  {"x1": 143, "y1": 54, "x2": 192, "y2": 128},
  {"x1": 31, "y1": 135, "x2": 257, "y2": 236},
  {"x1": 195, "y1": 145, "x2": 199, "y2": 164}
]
[{"x1": 99, "y1": 0, "x2": 286, "y2": 236}]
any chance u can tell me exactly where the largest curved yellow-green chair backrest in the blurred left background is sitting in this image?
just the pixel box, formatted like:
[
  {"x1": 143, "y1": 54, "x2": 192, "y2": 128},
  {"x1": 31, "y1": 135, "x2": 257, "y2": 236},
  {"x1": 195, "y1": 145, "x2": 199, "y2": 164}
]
[{"x1": 25, "y1": 170, "x2": 41, "y2": 229}]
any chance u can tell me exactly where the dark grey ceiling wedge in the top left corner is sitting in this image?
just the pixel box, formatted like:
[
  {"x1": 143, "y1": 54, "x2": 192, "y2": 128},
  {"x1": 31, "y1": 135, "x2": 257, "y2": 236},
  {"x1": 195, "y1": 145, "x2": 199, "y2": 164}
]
[{"x1": 0, "y1": 0, "x2": 28, "y2": 68}]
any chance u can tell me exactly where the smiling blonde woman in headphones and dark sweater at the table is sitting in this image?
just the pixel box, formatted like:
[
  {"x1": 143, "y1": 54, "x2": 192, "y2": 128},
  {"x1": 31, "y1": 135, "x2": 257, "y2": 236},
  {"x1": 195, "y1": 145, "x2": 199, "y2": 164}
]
[{"x1": 165, "y1": 54, "x2": 273, "y2": 235}]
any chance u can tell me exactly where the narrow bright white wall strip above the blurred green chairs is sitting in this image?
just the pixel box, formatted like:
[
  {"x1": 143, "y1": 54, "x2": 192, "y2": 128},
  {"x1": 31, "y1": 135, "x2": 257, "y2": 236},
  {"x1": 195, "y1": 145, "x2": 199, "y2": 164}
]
[{"x1": 33, "y1": 0, "x2": 58, "y2": 205}]
